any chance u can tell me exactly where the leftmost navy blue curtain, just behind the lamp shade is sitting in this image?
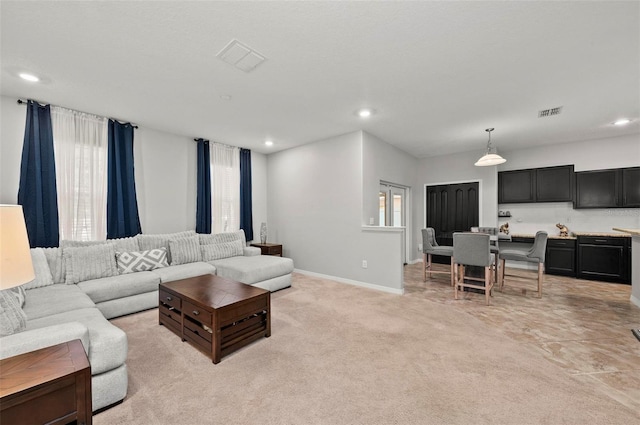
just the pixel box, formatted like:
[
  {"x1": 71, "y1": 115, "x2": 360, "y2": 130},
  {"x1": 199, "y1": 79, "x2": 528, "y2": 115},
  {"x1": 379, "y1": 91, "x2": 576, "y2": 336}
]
[{"x1": 18, "y1": 100, "x2": 60, "y2": 248}]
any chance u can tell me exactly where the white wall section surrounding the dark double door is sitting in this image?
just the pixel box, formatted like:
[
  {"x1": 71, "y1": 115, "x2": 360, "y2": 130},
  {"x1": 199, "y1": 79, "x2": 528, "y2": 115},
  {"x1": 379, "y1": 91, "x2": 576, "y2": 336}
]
[{"x1": 412, "y1": 151, "x2": 498, "y2": 259}]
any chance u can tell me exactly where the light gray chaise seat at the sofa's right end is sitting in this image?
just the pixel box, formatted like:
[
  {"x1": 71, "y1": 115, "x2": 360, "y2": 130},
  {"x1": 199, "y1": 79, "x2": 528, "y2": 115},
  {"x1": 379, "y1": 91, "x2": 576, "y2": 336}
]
[{"x1": 209, "y1": 255, "x2": 293, "y2": 285}]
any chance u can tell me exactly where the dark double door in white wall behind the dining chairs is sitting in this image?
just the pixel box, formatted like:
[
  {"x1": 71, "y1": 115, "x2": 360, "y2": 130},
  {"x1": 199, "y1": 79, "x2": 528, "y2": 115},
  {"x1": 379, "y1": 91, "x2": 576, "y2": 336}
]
[{"x1": 425, "y1": 182, "x2": 479, "y2": 263}]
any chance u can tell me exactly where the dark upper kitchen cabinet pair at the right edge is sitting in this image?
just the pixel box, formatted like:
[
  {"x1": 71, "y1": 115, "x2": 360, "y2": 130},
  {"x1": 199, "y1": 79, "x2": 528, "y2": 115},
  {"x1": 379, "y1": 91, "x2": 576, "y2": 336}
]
[{"x1": 575, "y1": 167, "x2": 640, "y2": 208}]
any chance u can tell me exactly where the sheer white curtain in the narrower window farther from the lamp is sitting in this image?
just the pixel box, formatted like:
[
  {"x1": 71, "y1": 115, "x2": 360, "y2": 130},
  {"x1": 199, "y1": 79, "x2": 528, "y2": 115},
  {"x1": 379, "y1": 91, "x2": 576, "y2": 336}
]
[{"x1": 211, "y1": 143, "x2": 240, "y2": 233}]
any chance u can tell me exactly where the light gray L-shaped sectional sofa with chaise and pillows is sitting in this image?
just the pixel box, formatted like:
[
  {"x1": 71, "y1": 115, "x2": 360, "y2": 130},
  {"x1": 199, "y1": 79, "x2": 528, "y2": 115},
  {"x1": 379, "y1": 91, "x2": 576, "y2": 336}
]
[{"x1": 0, "y1": 230, "x2": 293, "y2": 411}]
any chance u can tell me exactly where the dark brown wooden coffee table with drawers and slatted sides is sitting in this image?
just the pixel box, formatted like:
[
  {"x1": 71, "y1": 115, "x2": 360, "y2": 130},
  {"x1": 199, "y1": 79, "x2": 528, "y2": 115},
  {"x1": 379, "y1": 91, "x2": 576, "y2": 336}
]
[{"x1": 158, "y1": 275, "x2": 271, "y2": 363}]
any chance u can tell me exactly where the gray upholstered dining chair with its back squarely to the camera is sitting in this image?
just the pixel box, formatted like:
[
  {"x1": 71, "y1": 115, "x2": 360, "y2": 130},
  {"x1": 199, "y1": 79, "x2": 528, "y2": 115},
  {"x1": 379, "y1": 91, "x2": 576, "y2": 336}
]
[{"x1": 453, "y1": 232, "x2": 493, "y2": 305}]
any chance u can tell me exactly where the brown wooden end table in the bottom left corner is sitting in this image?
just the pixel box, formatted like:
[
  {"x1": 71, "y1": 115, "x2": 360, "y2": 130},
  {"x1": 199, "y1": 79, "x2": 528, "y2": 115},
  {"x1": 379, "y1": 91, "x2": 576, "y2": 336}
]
[{"x1": 0, "y1": 339, "x2": 92, "y2": 425}]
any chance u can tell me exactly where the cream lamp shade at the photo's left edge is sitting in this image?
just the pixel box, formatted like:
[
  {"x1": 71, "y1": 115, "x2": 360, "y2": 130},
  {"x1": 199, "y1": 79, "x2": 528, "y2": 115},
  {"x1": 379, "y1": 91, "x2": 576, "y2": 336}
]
[{"x1": 0, "y1": 205, "x2": 35, "y2": 289}]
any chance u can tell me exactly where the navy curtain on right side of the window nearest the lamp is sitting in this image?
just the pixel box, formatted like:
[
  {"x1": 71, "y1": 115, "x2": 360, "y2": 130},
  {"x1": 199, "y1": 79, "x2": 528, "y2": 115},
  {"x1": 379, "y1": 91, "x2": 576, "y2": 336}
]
[{"x1": 107, "y1": 120, "x2": 141, "y2": 239}]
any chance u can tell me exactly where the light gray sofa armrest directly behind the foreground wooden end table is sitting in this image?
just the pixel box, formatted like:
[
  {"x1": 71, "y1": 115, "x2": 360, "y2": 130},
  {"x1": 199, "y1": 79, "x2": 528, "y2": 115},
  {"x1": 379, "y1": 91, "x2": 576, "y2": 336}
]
[{"x1": 0, "y1": 322, "x2": 89, "y2": 359}]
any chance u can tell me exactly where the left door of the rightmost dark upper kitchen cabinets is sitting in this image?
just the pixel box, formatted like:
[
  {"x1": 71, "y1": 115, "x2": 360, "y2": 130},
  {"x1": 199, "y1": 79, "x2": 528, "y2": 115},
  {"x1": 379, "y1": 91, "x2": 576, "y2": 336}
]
[{"x1": 575, "y1": 170, "x2": 622, "y2": 208}]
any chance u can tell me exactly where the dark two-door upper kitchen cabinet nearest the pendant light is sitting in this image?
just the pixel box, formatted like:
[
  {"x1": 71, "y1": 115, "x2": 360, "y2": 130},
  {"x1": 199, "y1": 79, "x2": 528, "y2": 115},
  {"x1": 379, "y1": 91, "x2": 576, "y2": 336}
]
[{"x1": 498, "y1": 165, "x2": 574, "y2": 204}]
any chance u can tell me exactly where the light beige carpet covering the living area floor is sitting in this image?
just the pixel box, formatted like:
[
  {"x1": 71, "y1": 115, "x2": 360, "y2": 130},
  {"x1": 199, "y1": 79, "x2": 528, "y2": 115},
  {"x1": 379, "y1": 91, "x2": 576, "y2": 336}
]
[{"x1": 94, "y1": 274, "x2": 640, "y2": 425}]
